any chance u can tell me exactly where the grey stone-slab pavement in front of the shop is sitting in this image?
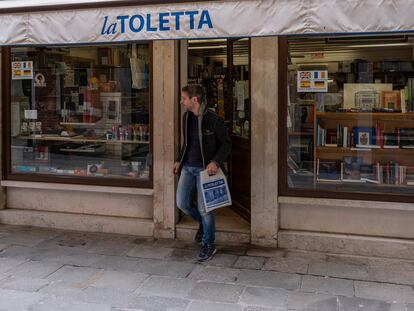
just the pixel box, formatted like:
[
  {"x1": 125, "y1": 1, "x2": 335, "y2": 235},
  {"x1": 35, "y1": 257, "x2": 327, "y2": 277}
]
[{"x1": 0, "y1": 225, "x2": 414, "y2": 311}]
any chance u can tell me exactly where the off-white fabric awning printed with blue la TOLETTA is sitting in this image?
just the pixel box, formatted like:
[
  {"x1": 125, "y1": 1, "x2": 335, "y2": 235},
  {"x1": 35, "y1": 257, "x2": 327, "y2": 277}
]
[{"x1": 0, "y1": 0, "x2": 414, "y2": 45}]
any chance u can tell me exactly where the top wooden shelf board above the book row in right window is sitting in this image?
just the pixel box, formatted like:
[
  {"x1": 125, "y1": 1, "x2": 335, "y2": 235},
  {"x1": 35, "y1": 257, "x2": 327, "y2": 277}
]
[{"x1": 316, "y1": 112, "x2": 414, "y2": 122}]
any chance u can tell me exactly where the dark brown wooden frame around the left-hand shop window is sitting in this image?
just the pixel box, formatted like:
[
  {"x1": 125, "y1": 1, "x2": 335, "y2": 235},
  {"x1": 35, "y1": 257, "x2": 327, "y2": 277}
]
[{"x1": 1, "y1": 41, "x2": 154, "y2": 189}]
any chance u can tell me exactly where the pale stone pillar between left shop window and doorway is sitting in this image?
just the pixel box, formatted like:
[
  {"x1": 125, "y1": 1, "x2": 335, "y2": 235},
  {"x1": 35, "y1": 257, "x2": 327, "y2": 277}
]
[{"x1": 152, "y1": 40, "x2": 179, "y2": 238}]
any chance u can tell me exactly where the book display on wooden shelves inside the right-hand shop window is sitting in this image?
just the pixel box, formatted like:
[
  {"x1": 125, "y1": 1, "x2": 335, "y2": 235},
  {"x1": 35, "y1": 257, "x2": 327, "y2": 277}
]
[{"x1": 287, "y1": 35, "x2": 414, "y2": 193}]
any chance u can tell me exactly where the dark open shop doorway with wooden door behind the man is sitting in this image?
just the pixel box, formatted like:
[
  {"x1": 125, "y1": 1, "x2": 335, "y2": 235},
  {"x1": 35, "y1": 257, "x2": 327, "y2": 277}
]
[{"x1": 185, "y1": 38, "x2": 251, "y2": 222}]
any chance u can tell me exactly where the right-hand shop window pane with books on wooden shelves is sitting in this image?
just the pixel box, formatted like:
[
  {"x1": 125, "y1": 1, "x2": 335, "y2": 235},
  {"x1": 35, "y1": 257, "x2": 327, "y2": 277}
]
[{"x1": 282, "y1": 36, "x2": 414, "y2": 199}]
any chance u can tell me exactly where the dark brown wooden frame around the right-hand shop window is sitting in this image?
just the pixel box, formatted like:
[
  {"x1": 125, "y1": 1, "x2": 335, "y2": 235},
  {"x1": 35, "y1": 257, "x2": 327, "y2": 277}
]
[{"x1": 278, "y1": 36, "x2": 414, "y2": 203}]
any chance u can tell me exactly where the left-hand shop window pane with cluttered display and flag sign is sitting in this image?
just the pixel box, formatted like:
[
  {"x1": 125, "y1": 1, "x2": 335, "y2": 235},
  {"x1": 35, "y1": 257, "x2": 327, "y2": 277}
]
[{"x1": 8, "y1": 44, "x2": 151, "y2": 185}]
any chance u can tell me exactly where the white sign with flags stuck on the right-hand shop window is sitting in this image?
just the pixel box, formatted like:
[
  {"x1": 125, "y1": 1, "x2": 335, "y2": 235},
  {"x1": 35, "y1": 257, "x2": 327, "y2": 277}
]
[{"x1": 298, "y1": 70, "x2": 328, "y2": 93}]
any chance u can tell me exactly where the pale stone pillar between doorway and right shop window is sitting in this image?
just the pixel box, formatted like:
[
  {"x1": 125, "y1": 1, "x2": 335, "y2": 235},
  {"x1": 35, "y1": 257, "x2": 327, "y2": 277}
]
[{"x1": 251, "y1": 37, "x2": 278, "y2": 247}]
